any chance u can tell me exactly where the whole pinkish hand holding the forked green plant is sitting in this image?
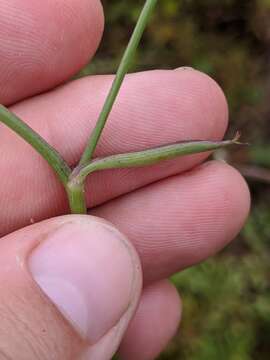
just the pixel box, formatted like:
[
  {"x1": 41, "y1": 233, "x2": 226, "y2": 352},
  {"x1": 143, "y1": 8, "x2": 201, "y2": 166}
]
[{"x1": 0, "y1": 0, "x2": 249, "y2": 360}]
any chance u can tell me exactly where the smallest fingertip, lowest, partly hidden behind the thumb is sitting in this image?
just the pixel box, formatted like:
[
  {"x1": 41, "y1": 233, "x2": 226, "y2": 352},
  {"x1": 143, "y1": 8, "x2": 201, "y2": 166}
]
[{"x1": 119, "y1": 280, "x2": 182, "y2": 360}]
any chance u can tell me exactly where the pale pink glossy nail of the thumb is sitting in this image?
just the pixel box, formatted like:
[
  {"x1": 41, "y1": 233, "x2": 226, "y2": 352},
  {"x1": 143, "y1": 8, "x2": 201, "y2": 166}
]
[{"x1": 28, "y1": 217, "x2": 137, "y2": 343}]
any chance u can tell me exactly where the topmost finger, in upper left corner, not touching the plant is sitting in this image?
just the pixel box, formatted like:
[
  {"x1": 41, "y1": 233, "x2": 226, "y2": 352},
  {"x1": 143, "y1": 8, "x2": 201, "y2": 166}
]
[{"x1": 0, "y1": 0, "x2": 104, "y2": 105}]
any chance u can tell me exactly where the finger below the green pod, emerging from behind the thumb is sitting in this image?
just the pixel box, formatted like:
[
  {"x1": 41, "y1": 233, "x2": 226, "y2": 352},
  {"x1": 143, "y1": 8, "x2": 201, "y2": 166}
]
[{"x1": 92, "y1": 161, "x2": 250, "y2": 283}]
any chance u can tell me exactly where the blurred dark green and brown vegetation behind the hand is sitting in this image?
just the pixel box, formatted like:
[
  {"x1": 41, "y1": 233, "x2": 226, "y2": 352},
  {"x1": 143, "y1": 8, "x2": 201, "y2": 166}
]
[{"x1": 78, "y1": 0, "x2": 270, "y2": 360}]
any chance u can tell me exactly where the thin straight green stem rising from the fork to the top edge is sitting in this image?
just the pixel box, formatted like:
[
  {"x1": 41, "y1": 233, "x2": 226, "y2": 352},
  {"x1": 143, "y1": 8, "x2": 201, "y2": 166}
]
[{"x1": 79, "y1": 0, "x2": 157, "y2": 166}]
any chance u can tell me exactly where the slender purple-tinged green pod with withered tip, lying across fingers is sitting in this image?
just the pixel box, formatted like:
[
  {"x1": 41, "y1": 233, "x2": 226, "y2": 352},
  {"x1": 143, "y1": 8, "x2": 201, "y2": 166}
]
[{"x1": 71, "y1": 134, "x2": 243, "y2": 184}]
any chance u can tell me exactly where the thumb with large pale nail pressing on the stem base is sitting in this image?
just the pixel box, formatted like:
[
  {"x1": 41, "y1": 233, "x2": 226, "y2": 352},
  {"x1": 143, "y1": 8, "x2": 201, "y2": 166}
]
[{"x1": 0, "y1": 215, "x2": 142, "y2": 360}]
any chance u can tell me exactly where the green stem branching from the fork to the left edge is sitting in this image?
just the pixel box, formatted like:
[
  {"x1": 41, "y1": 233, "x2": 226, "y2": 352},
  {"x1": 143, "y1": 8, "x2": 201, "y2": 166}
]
[{"x1": 0, "y1": 105, "x2": 71, "y2": 185}]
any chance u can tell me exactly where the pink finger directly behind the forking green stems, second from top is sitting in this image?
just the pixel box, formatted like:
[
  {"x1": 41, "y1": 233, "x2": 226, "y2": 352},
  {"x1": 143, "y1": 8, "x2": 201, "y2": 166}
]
[{"x1": 0, "y1": 70, "x2": 227, "y2": 234}]
